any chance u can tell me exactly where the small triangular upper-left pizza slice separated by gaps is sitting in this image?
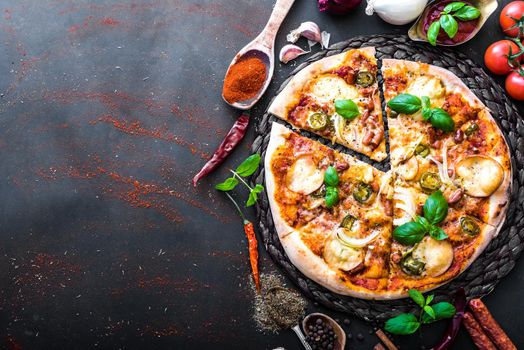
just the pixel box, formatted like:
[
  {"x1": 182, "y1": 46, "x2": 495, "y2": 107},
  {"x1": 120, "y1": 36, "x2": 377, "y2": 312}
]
[{"x1": 269, "y1": 47, "x2": 387, "y2": 161}]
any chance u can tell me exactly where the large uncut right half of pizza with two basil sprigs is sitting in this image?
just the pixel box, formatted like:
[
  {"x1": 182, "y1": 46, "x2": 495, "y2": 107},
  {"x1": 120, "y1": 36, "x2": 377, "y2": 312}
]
[{"x1": 382, "y1": 60, "x2": 512, "y2": 290}]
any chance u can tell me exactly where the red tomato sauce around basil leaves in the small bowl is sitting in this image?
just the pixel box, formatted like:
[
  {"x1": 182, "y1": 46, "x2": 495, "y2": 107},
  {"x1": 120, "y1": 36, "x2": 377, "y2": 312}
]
[{"x1": 423, "y1": 1, "x2": 480, "y2": 45}]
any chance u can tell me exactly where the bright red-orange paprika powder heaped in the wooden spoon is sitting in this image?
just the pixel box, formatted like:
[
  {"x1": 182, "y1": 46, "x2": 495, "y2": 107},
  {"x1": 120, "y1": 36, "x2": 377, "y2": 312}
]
[{"x1": 222, "y1": 57, "x2": 266, "y2": 103}]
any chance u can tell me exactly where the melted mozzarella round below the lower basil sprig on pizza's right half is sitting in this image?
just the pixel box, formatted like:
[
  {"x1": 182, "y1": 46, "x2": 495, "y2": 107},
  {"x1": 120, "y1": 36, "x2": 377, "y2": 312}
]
[{"x1": 412, "y1": 236, "x2": 453, "y2": 277}]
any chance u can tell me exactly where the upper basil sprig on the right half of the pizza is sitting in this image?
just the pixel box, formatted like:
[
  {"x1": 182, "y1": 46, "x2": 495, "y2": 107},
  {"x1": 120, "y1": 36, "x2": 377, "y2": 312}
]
[{"x1": 388, "y1": 94, "x2": 455, "y2": 132}]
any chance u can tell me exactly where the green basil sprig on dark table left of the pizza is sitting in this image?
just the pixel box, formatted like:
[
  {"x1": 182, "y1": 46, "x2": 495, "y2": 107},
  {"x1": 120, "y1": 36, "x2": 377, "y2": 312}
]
[{"x1": 215, "y1": 153, "x2": 264, "y2": 207}]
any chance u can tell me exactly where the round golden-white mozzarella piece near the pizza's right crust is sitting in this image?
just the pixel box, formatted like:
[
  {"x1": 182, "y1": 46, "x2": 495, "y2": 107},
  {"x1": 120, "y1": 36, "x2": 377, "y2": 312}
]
[{"x1": 456, "y1": 156, "x2": 504, "y2": 197}]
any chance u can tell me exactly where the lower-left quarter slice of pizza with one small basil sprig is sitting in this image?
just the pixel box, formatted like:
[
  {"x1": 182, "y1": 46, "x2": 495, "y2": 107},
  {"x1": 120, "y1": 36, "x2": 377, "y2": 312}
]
[{"x1": 265, "y1": 123, "x2": 392, "y2": 298}]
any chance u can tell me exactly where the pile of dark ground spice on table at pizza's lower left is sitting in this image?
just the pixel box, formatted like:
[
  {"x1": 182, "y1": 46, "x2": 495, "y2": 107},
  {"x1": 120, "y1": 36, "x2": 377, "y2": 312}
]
[{"x1": 251, "y1": 274, "x2": 307, "y2": 333}]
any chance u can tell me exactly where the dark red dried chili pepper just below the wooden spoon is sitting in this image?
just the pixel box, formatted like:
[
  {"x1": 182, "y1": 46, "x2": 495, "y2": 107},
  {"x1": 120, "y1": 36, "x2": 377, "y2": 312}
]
[{"x1": 193, "y1": 111, "x2": 249, "y2": 187}]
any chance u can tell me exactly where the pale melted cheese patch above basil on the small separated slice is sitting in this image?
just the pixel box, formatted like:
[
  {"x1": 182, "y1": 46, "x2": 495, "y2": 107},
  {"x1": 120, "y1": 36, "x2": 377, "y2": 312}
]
[{"x1": 310, "y1": 75, "x2": 359, "y2": 104}]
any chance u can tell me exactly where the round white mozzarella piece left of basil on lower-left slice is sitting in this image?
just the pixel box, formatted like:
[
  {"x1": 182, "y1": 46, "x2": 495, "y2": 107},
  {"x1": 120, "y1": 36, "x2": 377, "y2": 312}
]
[{"x1": 286, "y1": 156, "x2": 324, "y2": 195}]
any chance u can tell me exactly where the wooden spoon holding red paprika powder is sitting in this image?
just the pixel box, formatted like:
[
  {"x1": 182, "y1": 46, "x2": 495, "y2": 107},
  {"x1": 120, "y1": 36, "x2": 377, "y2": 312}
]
[{"x1": 222, "y1": 0, "x2": 295, "y2": 110}]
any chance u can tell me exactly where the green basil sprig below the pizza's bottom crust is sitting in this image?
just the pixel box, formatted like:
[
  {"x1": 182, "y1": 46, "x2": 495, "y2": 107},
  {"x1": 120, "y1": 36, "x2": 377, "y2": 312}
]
[{"x1": 384, "y1": 289, "x2": 457, "y2": 335}]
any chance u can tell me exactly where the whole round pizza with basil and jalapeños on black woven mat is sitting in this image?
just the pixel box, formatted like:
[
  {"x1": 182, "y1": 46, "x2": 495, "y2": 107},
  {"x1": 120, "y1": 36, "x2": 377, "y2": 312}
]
[{"x1": 265, "y1": 53, "x2": 512, "y2": 299}]
